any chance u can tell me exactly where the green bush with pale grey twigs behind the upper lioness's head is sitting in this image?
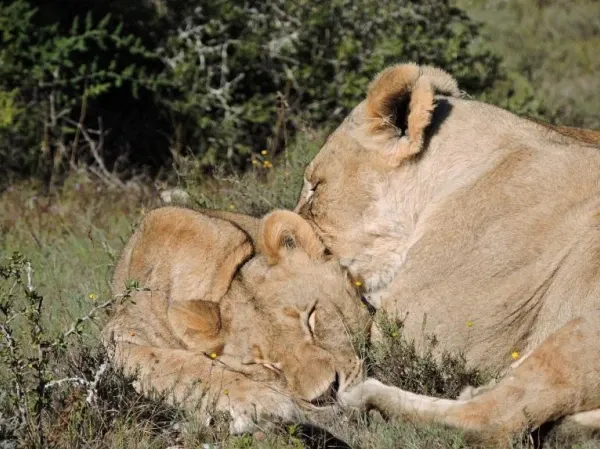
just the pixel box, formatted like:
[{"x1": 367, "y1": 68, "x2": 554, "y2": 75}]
[{"x1": 160, "y1": 0, "x2": 498, "y2": 167}]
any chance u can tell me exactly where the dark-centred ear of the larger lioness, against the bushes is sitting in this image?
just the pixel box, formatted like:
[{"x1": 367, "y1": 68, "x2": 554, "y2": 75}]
[{"x1": 357, "y1": 64, "x2": 460, "y2": 166}]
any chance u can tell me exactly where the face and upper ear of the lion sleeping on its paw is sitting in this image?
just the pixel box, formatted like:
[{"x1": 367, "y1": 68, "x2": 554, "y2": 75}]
[{"x1": 241, "y1": 211, "x2": 369, "y2": 401}]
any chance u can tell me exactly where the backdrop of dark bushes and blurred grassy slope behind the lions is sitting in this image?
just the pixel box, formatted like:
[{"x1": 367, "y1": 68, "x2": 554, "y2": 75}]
[{"x1": 0, "y1": 0, "x2": 600, "y2": 190}]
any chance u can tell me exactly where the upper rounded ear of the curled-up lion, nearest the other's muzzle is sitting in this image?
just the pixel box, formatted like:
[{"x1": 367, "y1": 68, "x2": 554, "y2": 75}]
[{"x1": 258, "y1": 210, "x2": 325, "y2": 265}]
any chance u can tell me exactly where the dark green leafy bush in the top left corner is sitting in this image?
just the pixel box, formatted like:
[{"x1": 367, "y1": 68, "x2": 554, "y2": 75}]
[{"x1": 0, "y1": 0, "x2": 164, "y2": 189}]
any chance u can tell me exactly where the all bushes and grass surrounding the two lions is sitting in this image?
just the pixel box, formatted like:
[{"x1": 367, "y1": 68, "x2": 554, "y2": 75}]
[{"x1": 0, "y1": 0, "x2": 600, "y2": 449}]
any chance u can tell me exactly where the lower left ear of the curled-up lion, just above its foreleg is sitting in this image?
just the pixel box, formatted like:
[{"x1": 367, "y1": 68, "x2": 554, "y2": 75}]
[{"x1": 167, "y1": 300, "x2": 222, "y2": 353}]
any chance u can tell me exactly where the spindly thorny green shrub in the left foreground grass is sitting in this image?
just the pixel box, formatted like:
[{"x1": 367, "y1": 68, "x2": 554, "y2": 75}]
[{"x1": 0, "y1": 253, "x2": 135, "y2": 448}]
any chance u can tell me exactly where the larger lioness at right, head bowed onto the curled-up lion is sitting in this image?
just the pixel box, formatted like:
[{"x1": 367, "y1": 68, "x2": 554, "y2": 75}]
[{"x1": 296, "y1": 64, "x2": 600, "y2": 438}]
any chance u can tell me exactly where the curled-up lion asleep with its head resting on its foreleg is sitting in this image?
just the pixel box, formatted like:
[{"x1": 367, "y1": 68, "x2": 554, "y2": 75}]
[{"x1": 104, "y1": 207, "x2": 369, "y2": 433}]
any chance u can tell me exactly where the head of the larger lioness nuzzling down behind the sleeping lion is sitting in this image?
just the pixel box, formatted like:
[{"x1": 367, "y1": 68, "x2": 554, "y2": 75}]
[{"x1": 295, "y1": 64, "x2": 460, "y2": 298}]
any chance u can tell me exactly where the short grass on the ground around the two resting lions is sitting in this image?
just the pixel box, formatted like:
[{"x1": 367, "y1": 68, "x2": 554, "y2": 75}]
[{"x1": 0, "y1": 133, "x2": 600, "y2": 449}]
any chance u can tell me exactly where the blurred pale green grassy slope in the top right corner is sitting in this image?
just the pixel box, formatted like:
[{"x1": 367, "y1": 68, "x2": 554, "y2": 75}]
[{"x1": 455, "y1": 0, "x2": 600, "y2": 129}]
